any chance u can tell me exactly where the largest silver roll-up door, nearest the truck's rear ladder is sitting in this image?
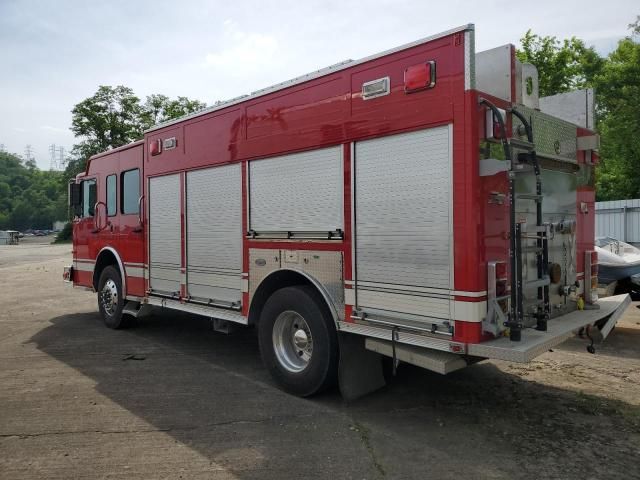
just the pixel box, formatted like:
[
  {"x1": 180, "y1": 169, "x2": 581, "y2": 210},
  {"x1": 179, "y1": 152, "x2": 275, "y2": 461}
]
[{"x1": 354, "y1": 126, "x2": 453, "y2": 320}]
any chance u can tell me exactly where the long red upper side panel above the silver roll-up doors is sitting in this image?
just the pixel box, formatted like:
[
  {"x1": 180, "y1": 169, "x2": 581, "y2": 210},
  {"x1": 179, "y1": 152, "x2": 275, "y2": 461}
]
[{"x1": 145, "y1": 36, "x2": 464, "y2": 166}]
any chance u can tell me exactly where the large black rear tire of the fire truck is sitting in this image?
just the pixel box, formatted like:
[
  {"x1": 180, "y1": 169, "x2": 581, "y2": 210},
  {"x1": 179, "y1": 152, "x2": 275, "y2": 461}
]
[{"x1": 258, "y1": 286, "x2": 338, "y2": 397}]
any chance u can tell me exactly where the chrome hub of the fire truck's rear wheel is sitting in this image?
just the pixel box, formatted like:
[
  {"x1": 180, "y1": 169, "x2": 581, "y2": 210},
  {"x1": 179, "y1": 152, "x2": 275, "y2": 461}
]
[{"x1": 272, "y1": 310, "x2": 313, "y2": 373}]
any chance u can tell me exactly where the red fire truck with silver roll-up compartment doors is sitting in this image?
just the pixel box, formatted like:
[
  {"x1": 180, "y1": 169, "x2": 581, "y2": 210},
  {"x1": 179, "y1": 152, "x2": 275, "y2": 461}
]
[{"x1": 64, "y1": 25, "x2": 629, "y2": 397}]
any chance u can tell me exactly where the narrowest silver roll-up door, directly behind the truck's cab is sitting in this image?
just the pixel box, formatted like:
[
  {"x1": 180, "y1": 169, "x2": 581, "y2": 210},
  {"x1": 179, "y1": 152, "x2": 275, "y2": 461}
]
[{"x1": 149, "y1": 174, "x2": 181, "y2": 295}]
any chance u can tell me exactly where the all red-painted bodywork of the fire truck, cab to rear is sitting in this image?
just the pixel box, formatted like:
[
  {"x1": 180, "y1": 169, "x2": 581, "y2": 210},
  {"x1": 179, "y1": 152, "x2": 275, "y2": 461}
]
[{"x1": 74, "y1": 27, "x2": 593, "y2": 348}]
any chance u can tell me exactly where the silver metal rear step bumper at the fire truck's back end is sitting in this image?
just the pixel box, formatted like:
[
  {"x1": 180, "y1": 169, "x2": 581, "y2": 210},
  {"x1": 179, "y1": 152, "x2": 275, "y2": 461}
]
[{"x1": 467, "y1": 294, "x2": 631, "y2": 363}]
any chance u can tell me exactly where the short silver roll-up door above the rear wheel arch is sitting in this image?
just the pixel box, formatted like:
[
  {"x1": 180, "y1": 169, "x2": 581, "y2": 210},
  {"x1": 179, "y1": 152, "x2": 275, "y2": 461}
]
[{"x1": 249, "y1": 146, "x2": 344, "y2": 233}]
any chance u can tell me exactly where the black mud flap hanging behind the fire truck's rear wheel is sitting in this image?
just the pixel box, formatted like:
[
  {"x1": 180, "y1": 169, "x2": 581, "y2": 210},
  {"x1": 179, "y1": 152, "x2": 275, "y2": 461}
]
[{"x1": 338, "y1": 333, "x2": 386, "y2": 401}]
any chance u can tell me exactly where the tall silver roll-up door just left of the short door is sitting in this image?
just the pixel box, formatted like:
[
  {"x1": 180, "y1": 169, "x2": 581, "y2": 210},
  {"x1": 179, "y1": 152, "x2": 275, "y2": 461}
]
[{"x1": 187, "y1": 164, "x2": 242, "y2": 303}]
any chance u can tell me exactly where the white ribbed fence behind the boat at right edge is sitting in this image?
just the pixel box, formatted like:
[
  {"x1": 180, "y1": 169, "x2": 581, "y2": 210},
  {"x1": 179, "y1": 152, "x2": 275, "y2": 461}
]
[{"x1": 596, "y1": 199, "x2": 640, "y2": 243}]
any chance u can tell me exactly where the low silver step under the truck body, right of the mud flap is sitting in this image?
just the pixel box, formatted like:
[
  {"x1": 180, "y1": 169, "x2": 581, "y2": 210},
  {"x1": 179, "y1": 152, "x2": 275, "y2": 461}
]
[{"x1": 364, "y1": 338, "x2": 468, "y2": 375}]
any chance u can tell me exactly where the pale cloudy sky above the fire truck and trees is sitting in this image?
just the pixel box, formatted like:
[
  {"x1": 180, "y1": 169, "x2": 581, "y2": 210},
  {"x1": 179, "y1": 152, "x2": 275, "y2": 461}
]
[{"x1": 0, "y1": 0, "x2": 640, "y2": 168}]
